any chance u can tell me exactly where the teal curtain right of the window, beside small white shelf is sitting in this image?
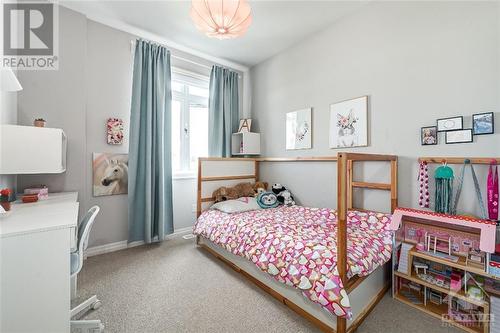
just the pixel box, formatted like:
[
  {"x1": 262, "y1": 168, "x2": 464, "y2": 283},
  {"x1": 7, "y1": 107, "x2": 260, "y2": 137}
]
[{"x1": 208, "y1": 66, "x2": 239, "y2": 157}]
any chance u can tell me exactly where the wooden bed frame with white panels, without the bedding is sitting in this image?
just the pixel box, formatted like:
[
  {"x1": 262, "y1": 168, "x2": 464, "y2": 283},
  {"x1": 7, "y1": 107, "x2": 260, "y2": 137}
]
[{"x1": 196, "y1": 153, "x2": 398, "y2": 333}]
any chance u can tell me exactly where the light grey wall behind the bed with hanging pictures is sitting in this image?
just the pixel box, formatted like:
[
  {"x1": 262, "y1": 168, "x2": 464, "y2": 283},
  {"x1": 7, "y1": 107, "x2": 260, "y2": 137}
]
[{"x1": 251, "y1": 1, "x2": 500, "y2": 213}]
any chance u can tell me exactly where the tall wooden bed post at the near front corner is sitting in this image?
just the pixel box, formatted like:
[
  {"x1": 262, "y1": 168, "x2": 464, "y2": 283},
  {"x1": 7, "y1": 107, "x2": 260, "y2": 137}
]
[{"x1": 337, "y1": 153, "x2": 348, "y2": 333}]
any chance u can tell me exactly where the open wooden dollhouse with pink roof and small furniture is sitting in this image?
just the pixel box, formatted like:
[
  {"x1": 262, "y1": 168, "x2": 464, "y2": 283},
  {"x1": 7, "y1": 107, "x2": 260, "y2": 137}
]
[{"x1": 391, "y1": 208, "x2": 500, "y2": 333}]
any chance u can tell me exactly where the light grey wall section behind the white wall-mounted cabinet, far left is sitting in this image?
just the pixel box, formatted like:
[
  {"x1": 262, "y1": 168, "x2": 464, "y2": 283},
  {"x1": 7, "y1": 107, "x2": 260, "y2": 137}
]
[{"x1": 17, "y1": 8, "x2": 90, "y2": 213}]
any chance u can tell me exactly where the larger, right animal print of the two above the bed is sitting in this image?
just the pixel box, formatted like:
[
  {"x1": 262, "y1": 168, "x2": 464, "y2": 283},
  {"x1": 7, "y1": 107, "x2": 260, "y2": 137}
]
[{"x1": 330, "y1": 96, "x2": 368, "y2": 148}]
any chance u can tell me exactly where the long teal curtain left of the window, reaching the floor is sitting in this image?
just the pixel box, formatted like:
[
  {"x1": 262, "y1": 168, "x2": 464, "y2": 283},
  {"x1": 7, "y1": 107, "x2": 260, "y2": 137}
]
[{"x1": 128, "y1": 40, "x2": 173, "y2": 243}]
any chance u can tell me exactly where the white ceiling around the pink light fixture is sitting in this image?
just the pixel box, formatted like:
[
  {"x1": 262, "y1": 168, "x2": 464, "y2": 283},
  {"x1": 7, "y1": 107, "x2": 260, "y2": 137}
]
[{"x1": 60, "y1": 0, "x2": 366, "y2": 67}]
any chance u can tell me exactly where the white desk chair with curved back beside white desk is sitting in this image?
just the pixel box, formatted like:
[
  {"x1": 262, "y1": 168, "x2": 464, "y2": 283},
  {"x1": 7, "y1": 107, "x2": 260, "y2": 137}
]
[{"x1": 70, "y1": 206, "x2": 104, "y2": 333}]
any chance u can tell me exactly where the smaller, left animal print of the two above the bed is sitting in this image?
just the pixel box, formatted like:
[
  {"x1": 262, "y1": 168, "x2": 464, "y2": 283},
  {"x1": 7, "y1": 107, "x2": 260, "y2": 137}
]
[{"x1": 285, "y1": 108, "x2": 312, "y2": 150}]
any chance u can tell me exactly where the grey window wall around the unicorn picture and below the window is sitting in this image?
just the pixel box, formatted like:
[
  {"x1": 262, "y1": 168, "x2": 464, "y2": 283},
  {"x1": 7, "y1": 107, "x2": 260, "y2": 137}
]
[{"x1": 85, "y1": 20, "x2": 199, "y2": 245}]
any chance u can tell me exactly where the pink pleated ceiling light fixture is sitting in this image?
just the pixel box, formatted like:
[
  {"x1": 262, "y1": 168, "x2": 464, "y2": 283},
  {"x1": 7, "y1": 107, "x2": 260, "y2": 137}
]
[{"x1": 190, "y1": 0, "x2": 252, "y2": 39}]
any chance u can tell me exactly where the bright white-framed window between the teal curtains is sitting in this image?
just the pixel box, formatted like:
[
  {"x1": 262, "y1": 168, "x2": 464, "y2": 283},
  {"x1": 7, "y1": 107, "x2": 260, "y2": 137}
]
[{"x1": 172, "y1": 69, "x2": 208, "y2": 177}]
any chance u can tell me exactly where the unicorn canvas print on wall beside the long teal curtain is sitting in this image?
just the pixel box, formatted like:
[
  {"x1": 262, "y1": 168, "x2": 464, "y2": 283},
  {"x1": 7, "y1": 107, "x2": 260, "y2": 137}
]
[{"x1": 92, "y1": 153, "x2": 128, "y2": 197}]
